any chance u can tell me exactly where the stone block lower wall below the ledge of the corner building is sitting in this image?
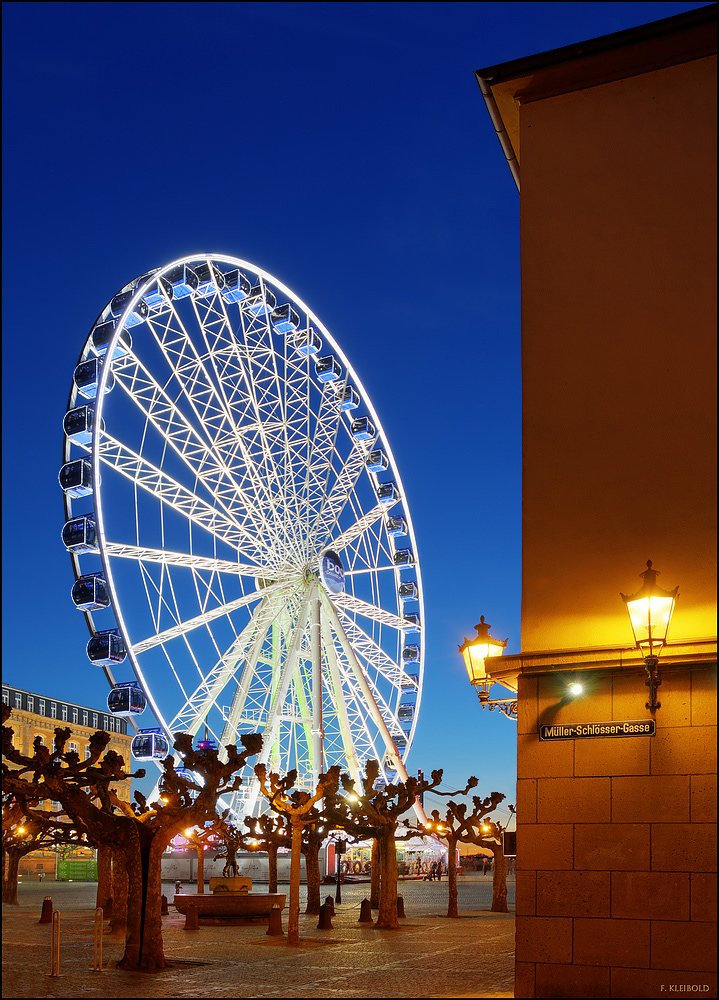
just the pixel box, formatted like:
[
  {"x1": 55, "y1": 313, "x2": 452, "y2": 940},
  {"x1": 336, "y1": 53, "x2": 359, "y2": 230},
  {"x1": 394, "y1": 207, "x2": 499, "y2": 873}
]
[{"x1": 515, "y1": 665, "x2": 716, "y2": 997}]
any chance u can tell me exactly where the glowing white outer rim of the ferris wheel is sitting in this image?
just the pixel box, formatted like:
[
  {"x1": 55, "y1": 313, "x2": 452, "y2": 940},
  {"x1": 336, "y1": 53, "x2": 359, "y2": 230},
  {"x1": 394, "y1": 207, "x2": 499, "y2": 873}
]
[{"x1": 65, "y1": 253, "x2": 424, "y2": 808}]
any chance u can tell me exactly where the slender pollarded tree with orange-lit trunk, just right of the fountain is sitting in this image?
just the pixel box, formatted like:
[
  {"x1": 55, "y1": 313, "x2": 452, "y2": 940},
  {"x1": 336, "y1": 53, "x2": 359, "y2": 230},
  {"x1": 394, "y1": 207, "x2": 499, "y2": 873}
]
[{"x1": 255, "y1": 764, "x2": 340, "y2": 945}]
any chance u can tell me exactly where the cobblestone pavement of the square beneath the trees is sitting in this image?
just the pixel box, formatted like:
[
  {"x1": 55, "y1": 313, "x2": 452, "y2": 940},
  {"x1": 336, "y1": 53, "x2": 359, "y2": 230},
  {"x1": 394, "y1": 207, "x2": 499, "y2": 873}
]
[{"x1": 2, "y1": 876, "x2": 514, "y2": 998}]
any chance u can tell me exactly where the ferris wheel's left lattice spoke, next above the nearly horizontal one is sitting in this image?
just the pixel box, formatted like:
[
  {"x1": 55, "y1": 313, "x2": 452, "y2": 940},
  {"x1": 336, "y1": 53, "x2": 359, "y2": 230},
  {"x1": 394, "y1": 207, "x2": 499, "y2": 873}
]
[{"x1": 99, "y1": 434, "x2": 265, "y2": 562}]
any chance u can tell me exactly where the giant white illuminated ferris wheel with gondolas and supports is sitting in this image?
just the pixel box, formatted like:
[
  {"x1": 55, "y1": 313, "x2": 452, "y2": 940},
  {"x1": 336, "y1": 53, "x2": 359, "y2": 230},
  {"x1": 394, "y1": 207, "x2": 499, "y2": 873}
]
[{"x1": 60, "y1": 254, "x2": 424, "y2": 815}]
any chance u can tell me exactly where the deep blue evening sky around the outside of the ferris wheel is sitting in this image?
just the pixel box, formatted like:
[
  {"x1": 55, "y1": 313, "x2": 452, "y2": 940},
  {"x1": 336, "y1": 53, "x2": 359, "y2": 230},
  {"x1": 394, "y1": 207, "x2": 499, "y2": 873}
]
[{"x1": 3, "y1": 2, "x2": 704, "y2": 816}]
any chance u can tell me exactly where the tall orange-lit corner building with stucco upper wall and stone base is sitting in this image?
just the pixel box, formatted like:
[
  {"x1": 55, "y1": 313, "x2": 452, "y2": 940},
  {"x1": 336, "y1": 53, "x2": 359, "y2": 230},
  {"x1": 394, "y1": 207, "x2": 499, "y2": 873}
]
[{"x1": 477, "y1": 5, "x2": 717, "y2": 997}]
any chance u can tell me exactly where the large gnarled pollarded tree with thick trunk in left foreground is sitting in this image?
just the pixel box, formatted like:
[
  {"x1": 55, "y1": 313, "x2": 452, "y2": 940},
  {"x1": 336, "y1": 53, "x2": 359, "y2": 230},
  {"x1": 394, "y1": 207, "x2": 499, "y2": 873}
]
[{"x1": 3, "y1": 713, "x2": 262, "y2": 969}]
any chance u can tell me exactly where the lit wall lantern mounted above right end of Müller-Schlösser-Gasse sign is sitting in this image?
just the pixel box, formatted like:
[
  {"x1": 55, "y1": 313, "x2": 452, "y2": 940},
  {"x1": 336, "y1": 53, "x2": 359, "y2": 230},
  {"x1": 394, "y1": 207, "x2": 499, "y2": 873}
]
[{"x1": 621, "y1": 559, "x2": 679, "y2": 712}]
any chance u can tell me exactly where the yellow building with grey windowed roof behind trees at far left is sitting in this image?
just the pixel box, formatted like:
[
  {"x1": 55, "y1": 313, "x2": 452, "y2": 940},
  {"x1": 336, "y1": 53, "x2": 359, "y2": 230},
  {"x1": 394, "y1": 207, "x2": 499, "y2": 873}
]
[{"x1": 2, "y1": 684, "x2": 132, "y2": 878}]
